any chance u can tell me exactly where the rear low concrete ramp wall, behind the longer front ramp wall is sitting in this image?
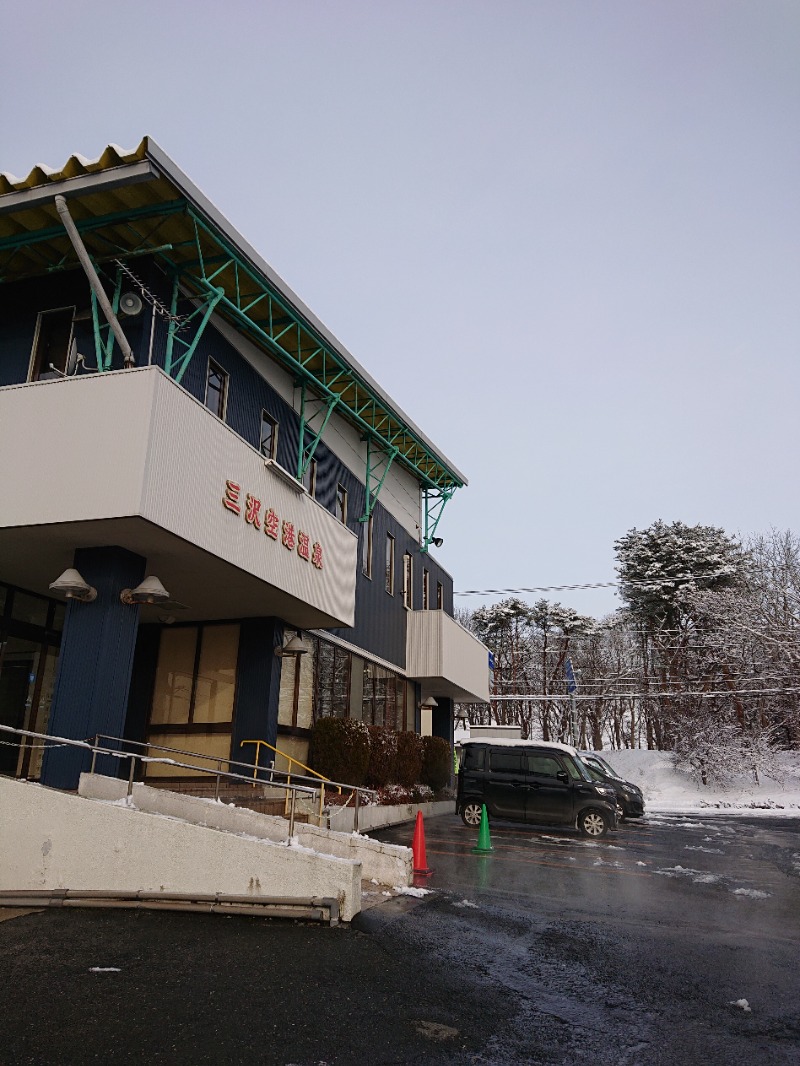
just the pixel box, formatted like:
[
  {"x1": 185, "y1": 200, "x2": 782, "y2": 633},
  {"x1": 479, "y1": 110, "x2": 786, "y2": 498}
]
[{"x1": 79, "y1": 774, "x2": 412, "y2": 886}]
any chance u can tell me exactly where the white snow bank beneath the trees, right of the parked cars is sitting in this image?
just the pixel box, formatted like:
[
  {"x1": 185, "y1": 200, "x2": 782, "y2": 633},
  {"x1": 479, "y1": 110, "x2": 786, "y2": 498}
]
[{"x1": 602, "y1": 748, "x2": 800, "y2": 818}]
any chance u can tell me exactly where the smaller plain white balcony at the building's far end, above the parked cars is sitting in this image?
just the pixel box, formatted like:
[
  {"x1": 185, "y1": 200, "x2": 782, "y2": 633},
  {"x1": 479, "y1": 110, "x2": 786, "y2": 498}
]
[{"x1": 405, "y1": 611, "x2": 490, "y2": 704}]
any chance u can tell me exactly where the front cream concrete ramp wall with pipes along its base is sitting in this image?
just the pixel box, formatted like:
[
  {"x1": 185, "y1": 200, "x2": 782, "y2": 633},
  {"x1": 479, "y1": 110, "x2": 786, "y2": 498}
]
[{"x1": 0, "y1": 777, "x2": 362, "y2": 921}]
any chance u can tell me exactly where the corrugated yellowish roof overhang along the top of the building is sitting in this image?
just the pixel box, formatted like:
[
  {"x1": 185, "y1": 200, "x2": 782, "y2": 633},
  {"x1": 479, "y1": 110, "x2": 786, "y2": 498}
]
[{"x1": 0, "y1": 138, "x2": 466, "y2": 498}]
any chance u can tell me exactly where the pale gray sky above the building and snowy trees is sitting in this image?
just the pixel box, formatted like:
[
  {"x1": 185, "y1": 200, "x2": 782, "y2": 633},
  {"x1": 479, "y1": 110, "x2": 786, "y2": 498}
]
[{"x1": 0, "y1": 0, "x2": 800, "y2": 615}]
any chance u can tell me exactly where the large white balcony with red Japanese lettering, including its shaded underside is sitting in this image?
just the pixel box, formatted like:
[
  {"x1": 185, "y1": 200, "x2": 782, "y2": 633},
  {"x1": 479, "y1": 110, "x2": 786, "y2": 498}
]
[{"x1": 0, "y1": 367, "x2": 357, "y2": 629}]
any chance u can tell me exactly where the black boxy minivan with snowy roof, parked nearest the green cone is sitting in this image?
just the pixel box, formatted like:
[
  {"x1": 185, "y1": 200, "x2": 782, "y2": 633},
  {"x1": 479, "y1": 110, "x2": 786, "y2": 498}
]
[{"x1": 457, "y1": 739, "x2": 617, "y2": 837}]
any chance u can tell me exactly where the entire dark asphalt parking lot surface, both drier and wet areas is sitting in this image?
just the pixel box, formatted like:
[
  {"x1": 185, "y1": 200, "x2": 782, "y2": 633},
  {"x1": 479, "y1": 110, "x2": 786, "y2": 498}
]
[{"x1": 0, "y1": 814, "x2": 800, "y2": 1066}]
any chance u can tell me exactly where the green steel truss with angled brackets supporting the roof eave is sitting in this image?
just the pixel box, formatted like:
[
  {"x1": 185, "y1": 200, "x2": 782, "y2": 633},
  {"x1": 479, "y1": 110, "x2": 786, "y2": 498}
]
[{"x1": 0, "y1": 198, "x2": 463, "y2": 530}]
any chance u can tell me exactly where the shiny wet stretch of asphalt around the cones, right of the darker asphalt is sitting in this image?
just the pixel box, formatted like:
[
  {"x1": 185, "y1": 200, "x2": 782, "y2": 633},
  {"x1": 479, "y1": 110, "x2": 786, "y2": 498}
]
[{"x1": 365, "y1": 814, "x2": 800, "y2": 1066}]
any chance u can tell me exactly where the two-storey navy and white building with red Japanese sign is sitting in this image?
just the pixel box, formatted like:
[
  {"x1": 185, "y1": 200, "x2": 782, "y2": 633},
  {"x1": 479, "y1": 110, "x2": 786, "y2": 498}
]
[{"x1": 0, "y1": 138, "x2": 489, "y2": 788}]
